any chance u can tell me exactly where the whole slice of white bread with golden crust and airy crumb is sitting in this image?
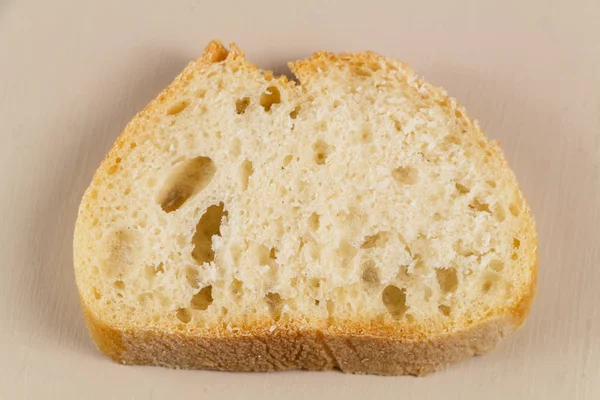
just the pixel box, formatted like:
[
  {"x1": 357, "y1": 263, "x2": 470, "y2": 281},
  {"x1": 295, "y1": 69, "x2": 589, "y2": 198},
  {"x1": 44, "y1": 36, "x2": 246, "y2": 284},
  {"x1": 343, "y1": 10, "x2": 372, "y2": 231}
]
[{"x1": 74, "y1": 42, "x2": 537, "y2": 375}]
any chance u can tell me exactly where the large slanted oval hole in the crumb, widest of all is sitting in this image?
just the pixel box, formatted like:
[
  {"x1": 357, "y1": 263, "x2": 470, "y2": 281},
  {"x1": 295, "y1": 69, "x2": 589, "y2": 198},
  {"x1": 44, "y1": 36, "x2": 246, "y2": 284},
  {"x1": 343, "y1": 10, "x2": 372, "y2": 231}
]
[{"x1": 157, "y1": 157, "x2": 217, "y2": 213}]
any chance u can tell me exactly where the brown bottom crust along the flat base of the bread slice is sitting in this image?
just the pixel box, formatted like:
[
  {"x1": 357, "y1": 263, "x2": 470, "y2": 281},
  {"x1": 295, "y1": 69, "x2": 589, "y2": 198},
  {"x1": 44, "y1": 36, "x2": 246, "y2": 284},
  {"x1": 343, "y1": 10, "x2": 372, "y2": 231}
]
[{"x1": 83, "y1": 293, "x2": 533, "y2": 375}]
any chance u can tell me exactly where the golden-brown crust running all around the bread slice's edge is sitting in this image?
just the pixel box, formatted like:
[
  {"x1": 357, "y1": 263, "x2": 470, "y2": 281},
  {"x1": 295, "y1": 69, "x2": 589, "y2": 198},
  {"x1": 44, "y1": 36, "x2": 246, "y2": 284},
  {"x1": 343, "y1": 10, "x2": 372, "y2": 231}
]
[{"x1": 74, "y1": 41, "x2": 537, "y2": 375}]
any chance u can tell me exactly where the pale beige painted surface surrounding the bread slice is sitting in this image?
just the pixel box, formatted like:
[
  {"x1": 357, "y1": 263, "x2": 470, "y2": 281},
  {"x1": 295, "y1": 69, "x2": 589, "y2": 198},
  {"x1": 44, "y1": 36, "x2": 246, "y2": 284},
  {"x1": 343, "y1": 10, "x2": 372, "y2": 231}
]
[{"x1": 0, "y1": 0, "x2": 600, "y2": 400}]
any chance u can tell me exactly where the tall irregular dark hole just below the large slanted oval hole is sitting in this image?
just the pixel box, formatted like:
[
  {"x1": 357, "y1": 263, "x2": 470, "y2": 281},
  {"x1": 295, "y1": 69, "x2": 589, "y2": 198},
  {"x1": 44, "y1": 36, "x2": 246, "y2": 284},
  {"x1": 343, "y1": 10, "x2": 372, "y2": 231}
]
[{"x1": 192, "y1": 203, "x2": 227, "y2": 265}]
